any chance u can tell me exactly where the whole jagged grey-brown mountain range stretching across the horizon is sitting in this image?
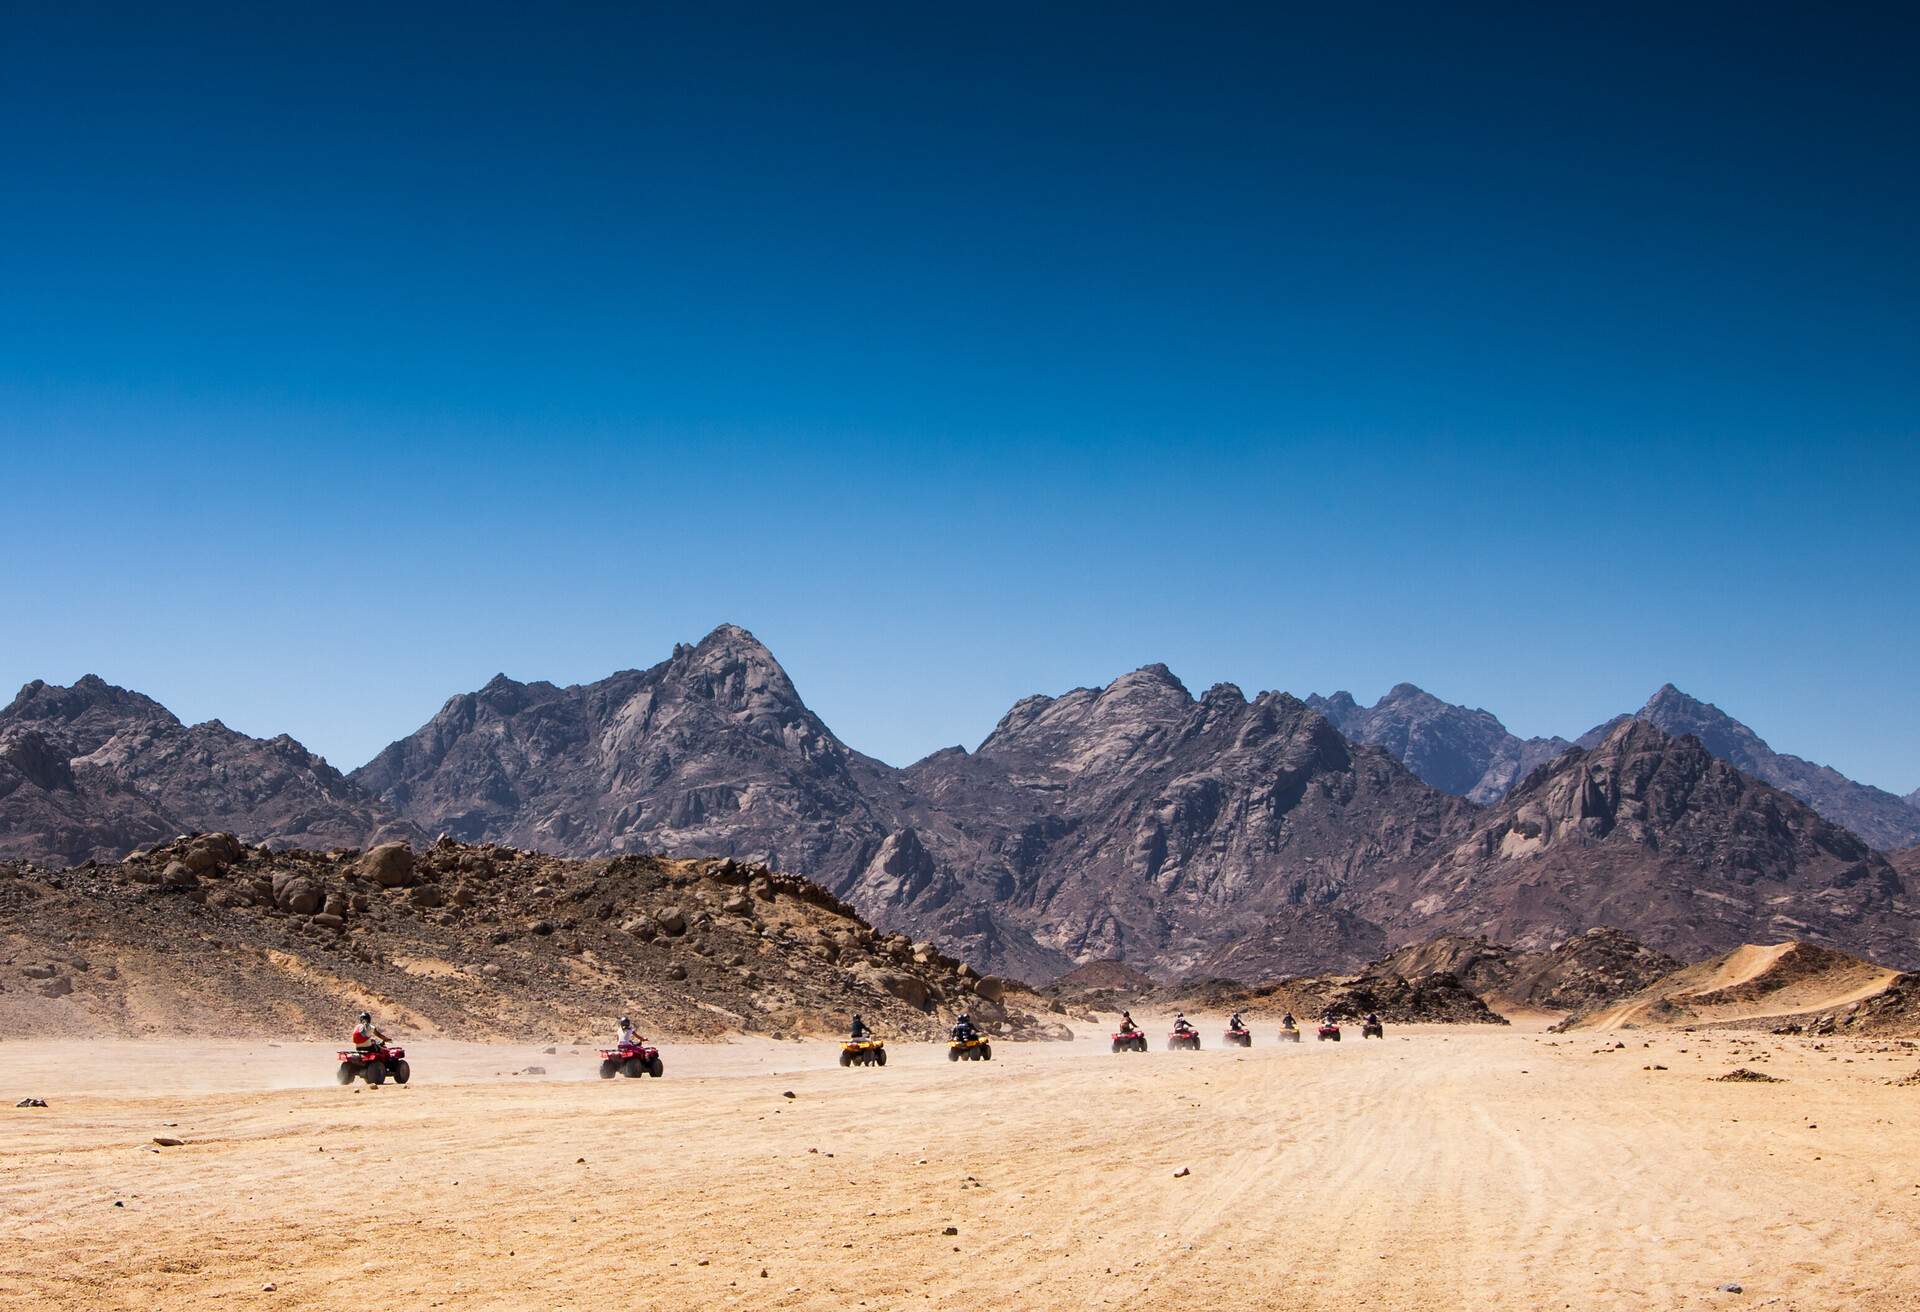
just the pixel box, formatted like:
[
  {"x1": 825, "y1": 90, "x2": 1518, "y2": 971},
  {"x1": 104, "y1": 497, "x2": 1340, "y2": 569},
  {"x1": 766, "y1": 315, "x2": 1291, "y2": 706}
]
[{"x1": 0, "y1": 624, "x2": 1920, "y2": 980}]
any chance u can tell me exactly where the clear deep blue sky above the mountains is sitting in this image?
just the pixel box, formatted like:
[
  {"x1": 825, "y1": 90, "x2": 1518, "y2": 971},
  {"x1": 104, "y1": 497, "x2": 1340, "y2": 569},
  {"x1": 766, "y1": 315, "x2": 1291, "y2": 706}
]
[{"x1": 0, "y1": 4, "x2": 1920, "y2": 791}]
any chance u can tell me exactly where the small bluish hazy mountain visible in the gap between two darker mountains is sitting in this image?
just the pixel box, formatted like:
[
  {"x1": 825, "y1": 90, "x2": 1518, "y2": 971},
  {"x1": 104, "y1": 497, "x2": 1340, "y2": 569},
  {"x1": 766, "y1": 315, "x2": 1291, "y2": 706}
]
[{"x1": 1308, "y1": 684, "x2": 1572, "y2": 805}]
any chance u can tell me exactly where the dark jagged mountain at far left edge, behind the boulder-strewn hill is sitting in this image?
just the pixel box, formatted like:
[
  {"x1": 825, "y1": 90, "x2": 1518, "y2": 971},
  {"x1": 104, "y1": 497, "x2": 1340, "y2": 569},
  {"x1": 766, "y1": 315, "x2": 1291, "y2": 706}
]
[{"x1": 0, "y1": 674, "x2": 419, "y2": 864}]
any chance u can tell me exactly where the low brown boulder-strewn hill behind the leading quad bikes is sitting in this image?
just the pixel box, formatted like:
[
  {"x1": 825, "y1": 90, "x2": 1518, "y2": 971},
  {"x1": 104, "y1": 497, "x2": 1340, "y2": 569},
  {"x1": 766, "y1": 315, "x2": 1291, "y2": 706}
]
[{"x1": 0, "y1": 834, "x2": 1068, "y2": 1039}]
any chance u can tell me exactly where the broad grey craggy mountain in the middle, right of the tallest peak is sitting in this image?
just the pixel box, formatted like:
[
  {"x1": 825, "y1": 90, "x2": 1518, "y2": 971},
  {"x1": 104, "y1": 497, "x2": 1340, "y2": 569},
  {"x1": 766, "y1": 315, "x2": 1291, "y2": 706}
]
[{"x1": 879, "y1": 665, "x2": 1471, "y2": 974}]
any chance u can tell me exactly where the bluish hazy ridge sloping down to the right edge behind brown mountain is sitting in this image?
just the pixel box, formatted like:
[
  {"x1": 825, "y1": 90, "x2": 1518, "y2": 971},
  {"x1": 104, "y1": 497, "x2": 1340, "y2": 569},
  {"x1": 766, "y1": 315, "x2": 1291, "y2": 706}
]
[{"x1": 1578, "y1": 684, "x2": 1920, "y2": 851}]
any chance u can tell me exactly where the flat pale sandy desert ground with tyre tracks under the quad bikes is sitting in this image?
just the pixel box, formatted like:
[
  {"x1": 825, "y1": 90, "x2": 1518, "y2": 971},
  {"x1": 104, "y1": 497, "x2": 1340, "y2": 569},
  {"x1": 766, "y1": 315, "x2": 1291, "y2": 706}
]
[{"x1": 0, "y1": 1024, "x2": 1920, "y2": 1312}]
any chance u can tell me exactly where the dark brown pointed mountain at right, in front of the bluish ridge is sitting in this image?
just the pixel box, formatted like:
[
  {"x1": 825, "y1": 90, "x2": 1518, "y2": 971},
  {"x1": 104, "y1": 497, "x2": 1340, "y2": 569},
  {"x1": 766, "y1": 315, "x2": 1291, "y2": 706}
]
[{"x1": 1357, "y1": 718, "x2": 1920, "y2": 964}]
